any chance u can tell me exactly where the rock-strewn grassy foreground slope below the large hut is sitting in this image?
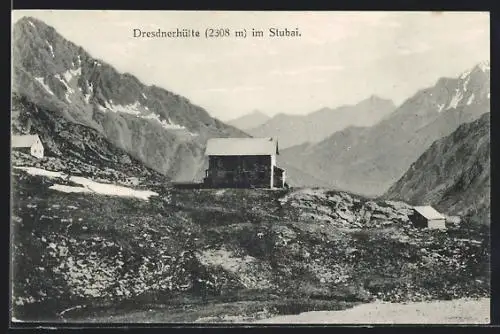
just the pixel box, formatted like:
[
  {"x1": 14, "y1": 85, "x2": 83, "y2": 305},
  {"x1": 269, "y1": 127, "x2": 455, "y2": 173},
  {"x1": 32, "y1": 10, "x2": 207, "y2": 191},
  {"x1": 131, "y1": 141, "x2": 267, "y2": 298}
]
[{"x1": 13, "y1": 170, "x2": 489, "y2": 322}]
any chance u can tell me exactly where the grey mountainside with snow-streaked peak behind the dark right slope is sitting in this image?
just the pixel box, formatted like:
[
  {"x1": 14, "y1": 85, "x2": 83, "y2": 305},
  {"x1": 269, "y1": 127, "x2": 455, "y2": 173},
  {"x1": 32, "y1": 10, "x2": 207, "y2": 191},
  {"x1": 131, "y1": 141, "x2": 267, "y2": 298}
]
[{"x1": 280, "y1": 63, "x2": 490, "y2": 196}]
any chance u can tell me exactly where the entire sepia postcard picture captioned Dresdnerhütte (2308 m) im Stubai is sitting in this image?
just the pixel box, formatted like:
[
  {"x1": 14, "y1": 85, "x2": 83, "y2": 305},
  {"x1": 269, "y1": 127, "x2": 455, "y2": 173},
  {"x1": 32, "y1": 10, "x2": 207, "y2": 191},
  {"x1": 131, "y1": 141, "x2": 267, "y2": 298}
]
[{"x1": 9, "y1": 10, "x2": 491, "y2": 326}]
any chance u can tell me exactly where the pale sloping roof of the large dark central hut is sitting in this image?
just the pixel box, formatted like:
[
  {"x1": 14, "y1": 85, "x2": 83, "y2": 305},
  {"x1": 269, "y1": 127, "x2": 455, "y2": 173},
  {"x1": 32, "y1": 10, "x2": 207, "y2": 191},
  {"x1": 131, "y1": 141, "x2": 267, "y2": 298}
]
[{"x1": 205, "y1": 138, "x2": 279, "y2": 156}]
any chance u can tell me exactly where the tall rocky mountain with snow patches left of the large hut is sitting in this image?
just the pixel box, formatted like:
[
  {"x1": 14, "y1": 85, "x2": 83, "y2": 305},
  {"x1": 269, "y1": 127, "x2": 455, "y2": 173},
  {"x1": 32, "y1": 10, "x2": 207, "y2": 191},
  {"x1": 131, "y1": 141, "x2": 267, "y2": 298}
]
[{"x1": 12, "y1": 17, "x2": 248, "y2": 180}]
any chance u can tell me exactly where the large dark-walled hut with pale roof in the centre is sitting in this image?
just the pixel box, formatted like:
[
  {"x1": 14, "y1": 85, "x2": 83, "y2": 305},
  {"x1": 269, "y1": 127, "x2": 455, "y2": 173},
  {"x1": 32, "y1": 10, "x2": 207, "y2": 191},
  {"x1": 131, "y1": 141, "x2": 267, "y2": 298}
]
[{"x1": 204, "y1": 138, "x2": 285, "y2": 189}]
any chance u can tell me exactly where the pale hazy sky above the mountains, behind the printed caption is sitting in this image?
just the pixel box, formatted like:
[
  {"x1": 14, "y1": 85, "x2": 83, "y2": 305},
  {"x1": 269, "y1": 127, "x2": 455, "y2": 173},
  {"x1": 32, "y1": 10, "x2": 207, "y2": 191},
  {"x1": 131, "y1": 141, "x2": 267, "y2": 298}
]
[{"x1": 13, "y1": 11, "x2": 490, "y2": 120}]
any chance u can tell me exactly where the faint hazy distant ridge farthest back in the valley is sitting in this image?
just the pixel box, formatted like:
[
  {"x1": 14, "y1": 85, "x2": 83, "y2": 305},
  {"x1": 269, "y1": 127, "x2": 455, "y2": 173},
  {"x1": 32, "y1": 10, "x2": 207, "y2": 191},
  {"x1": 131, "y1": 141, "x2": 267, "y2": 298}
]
[{"x1": 246, "y1": 96, "x2": 395, "y2": 148}]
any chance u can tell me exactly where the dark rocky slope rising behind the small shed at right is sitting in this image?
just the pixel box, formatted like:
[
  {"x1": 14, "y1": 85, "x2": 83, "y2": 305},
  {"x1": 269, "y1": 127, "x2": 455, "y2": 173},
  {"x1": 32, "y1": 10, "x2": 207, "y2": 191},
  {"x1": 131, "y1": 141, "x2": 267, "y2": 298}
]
[{"x1": 385, "y1": 113, "x2": 491, "y2": 224}]
